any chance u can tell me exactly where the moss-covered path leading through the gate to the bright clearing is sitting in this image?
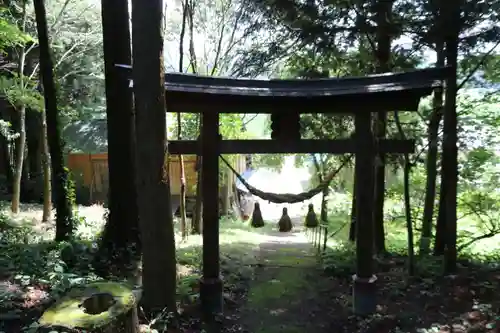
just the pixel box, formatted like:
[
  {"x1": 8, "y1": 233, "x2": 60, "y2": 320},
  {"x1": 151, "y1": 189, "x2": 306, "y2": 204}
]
[{"x1": 242, "y1": 226, "x2": 330, "y2": 333}]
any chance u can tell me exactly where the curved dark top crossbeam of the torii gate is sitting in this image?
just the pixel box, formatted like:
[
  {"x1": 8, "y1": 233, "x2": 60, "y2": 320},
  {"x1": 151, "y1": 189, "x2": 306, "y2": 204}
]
[{"x1": 116, "y1": 65, "x2": 450, "y2": 114}]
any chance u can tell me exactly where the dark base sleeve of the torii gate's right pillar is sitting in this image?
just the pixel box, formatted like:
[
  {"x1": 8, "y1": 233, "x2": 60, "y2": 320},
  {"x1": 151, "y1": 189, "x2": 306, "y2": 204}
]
[{"x1": 352, "y1": 275, "x2": 377, "y2": 316}]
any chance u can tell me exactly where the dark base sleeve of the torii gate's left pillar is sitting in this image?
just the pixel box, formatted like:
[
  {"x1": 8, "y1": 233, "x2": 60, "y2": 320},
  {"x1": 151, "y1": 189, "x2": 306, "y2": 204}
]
[{"x1": 200, "y1": 277, "x2": 224, "y2": 321}]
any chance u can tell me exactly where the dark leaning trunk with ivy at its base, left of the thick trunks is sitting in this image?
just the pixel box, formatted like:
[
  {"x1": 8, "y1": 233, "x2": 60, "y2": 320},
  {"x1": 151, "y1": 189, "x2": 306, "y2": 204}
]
[{"x1": 33, "y1": 0, "x2": 73, "y2": 242}]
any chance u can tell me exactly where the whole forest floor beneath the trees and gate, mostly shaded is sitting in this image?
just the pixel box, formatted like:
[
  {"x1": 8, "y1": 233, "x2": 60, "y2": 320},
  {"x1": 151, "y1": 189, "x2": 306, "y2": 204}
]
[{"x1": 0, "y1": 215, "x2": 500, "y2": 333}]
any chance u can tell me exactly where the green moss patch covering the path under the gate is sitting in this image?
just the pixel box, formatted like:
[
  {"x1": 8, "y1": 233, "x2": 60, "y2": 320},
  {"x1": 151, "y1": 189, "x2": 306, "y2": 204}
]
[{"x1": 242, "y1": 239, "x2": 324, "y2": 333}]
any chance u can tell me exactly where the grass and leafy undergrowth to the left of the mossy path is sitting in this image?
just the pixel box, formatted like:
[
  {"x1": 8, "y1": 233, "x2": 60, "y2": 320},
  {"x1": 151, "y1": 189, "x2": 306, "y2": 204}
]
[{"x1": 0, "y1": 203, "x2": 282, "y2": 332}]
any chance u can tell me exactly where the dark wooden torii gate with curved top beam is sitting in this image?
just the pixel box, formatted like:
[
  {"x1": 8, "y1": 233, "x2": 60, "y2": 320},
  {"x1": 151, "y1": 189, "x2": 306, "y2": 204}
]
[{"x1": 124, "y1": 68, "x2": 450, "y2": 314}]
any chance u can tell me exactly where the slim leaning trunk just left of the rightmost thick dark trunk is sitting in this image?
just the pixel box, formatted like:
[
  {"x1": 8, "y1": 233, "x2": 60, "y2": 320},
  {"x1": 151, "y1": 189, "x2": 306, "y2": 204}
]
[{"x1": 420, "y1": 42, "x2": 444, "y2": 254}]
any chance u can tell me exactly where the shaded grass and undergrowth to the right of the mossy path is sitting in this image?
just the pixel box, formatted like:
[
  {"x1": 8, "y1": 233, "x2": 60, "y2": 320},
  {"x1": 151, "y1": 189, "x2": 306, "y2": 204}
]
[{"x1": 312, "y1": 195, "x2": 500, "y2": 333}]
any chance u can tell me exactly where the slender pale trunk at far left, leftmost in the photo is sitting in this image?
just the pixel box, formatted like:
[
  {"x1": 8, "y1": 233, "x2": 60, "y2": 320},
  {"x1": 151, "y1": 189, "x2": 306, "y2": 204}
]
[{"x1": 11, "y1": 1, "x2": 27, "y2": 214}]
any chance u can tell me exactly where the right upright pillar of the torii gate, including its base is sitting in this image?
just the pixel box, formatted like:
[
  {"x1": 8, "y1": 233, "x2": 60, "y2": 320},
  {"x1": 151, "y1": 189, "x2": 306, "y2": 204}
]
[{"x1": 353, "y1": 113, "x2": 377, "y2": 315}]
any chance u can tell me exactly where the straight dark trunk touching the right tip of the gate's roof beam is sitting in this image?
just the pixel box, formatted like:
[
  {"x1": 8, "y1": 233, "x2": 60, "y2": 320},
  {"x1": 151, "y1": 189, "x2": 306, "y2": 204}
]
[{"x1": 442, "y1": 1, "x2": 462, "y2": 274}]
